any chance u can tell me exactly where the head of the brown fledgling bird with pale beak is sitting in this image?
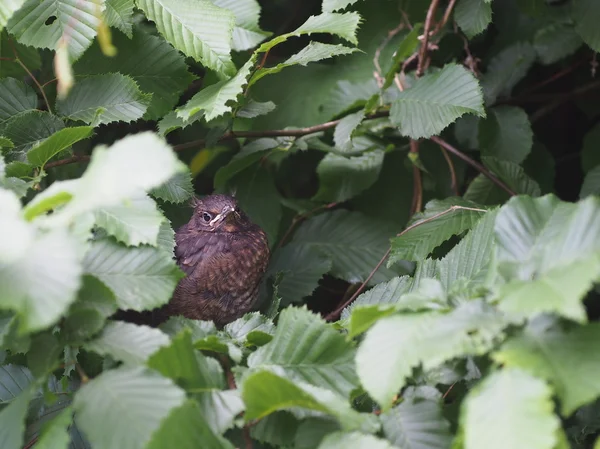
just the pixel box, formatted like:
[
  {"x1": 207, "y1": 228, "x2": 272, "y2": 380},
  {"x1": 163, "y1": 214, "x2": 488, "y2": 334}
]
[{"x1": 192, "y1": 195, "x2": 248, "y2": 232}]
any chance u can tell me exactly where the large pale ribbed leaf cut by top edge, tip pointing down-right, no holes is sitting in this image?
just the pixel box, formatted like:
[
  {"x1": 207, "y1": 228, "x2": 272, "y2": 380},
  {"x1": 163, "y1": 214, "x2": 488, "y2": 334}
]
[{"x1": 136, "y1": 0, "x2": 235, "y2": 77}]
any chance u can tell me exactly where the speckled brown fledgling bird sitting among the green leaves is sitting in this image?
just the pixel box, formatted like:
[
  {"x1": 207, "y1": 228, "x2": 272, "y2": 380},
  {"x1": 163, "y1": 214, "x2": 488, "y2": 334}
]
[{"x1": 163, "y1": 195, "x2": 269, "y2": 326}]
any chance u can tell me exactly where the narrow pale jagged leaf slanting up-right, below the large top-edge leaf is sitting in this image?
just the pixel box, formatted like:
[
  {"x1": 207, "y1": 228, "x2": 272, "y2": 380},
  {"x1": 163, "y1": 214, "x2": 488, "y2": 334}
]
[{"x1": 177, "y1": 57, "x2": 255, "y2": 122}]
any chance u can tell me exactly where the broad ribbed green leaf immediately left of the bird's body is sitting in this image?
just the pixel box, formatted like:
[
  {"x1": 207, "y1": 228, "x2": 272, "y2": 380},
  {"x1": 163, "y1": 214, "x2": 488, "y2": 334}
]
[{"x1": 83, "y1": 239, "x2": 183, "y2": 311}]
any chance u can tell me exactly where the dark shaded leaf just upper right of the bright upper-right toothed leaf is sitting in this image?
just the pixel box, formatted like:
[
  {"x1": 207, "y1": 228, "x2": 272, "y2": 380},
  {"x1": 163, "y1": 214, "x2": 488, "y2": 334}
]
[{"x1": 481, "y1": 42, "x2": 536, "y2": 105}]
